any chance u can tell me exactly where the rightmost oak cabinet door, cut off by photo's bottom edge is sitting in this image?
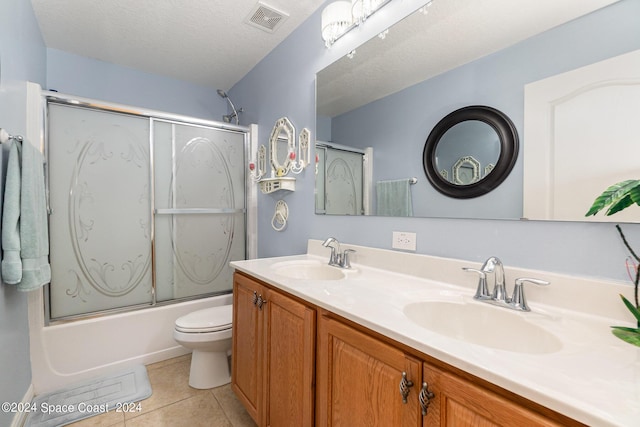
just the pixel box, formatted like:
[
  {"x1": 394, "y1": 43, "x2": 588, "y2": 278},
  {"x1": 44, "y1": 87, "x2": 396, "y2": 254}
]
[{"x1": 423, "y1": 364, "x2": 563, "y2": 427}]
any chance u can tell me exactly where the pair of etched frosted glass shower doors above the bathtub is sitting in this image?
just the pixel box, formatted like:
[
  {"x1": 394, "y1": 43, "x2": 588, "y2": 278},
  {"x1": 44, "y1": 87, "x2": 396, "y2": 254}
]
[{"x1": 47, "y1": 101, "x2": 247, "y2": 320}]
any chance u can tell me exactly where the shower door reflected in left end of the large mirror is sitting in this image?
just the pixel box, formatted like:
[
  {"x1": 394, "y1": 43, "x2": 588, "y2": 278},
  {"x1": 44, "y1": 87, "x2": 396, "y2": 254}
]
[{"x1": 316, "y1": 142, "x2": 371, "y2": 215}]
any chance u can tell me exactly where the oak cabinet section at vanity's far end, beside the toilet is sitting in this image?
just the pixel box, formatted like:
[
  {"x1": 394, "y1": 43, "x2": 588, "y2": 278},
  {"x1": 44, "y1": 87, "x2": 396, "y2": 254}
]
[{"x1": 231, "y1": 273, "x2": 316, "y2": 427}]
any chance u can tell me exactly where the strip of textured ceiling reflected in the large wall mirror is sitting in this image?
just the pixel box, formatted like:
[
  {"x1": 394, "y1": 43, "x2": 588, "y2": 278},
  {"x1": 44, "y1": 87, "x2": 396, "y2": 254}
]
[{"x1": 317, "y1": 0, "x2": 618, "y2": 117}]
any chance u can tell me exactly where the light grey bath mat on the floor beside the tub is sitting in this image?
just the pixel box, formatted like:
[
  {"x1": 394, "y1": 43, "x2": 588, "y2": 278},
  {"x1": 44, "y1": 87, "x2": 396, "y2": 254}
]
[{"x1": 25, "y1": 365, "x2": 151, "y2": 427}]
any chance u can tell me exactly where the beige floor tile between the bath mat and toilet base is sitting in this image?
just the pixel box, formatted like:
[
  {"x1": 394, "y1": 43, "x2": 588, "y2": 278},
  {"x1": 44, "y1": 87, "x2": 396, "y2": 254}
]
[{"x1": 130, "y1": 357, "x2": 207, "y2": 420}]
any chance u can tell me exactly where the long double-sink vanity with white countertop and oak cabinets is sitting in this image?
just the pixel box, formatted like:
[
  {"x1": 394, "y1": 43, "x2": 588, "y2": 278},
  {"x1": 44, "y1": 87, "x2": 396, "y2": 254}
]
[{"x1": 232, "y1": 241, "x2": 640, "y2": 426}]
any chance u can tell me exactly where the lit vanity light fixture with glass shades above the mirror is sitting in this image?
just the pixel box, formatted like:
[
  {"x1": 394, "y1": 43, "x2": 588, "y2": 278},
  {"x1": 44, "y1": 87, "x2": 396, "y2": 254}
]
[{"x1": 321, "y1": 0, "x2": 391, "y2": 47}]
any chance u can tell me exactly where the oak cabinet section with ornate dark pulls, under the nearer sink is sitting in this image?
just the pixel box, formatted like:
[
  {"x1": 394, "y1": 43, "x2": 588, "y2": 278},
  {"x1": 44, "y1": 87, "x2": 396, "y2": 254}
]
[{"x1": 316, "y1": 310, "x2": 581, "y2": 427}]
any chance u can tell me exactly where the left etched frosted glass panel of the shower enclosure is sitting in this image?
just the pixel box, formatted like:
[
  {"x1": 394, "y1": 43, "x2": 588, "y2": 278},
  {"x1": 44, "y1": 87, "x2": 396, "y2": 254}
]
[{"x1": 48, "y1": 104, "x2": 151, "y2": 318}]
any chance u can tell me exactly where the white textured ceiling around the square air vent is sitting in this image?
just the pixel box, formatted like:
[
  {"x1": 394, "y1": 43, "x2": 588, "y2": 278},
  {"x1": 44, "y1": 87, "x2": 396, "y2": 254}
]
[{"x1": 31, "y1": 0, "x2": 323, "y2": 90}]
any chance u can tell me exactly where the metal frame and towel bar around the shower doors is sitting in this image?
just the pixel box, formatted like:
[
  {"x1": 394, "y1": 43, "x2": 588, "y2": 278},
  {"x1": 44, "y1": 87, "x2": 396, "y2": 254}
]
[{"x1": 41, "y1": 91, "x2": 252, "y2": 326}]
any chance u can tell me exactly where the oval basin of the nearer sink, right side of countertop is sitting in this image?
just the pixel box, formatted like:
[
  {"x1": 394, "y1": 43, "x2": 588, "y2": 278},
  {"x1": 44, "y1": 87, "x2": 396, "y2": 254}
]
[{"x1": 404, "y1": 301, "x2": 562, "y2": 354}]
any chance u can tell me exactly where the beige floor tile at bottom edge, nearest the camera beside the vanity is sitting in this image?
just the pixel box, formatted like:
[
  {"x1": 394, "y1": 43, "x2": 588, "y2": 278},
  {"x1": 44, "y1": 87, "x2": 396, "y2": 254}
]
[{"x1": 126, "y1": 393, "x2": 233, "y2": 427}]
